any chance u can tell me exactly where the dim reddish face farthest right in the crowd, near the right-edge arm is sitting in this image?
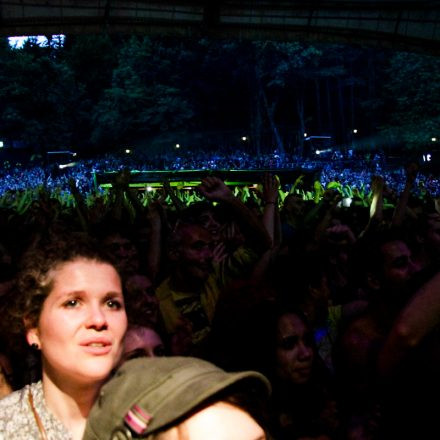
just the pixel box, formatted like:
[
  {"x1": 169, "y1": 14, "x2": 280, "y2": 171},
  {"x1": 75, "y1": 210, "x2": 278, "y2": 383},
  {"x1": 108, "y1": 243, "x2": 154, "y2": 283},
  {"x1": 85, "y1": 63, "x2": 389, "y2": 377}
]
[{"x1": 381, "y1": 240, "x2": 418, "y2": 288}]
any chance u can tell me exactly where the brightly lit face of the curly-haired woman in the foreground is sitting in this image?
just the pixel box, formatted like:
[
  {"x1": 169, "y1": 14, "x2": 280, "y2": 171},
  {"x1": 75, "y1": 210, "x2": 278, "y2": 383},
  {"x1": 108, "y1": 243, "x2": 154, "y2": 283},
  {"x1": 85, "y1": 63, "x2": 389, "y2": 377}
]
[{"x1": 27, "y1": 258, "x2": 127, "y2": 384}]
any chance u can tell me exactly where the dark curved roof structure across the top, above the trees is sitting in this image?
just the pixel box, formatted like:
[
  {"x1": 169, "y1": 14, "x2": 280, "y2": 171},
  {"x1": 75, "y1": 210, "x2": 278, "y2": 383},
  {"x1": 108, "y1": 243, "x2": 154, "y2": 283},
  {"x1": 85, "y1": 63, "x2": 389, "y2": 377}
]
[{"x1": 0, "y1": 0, "x2": 440, "y2": 55}]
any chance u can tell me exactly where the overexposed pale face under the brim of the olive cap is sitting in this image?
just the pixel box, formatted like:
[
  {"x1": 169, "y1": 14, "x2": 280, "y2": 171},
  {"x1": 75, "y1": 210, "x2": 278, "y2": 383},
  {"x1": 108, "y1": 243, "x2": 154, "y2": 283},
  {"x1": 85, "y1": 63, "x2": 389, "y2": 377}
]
[{"x1": 155, "y1": 402, "x2": 266, "y2": 440}]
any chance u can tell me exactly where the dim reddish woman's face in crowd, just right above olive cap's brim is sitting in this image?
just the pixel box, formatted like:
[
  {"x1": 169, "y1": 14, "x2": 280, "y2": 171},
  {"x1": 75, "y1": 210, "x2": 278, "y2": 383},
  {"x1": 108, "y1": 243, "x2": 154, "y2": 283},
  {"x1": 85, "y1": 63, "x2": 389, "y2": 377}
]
[{"x1": 276, "y1": 313, "x2": 314, "y2": 385}]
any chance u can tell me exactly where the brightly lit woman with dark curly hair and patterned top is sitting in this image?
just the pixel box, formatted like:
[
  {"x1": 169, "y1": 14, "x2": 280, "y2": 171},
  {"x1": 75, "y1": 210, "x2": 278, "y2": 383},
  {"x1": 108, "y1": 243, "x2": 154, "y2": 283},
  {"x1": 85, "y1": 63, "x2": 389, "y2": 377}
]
[{"x1": 0, "y1": 234, "x2": 127, "y2": 440}]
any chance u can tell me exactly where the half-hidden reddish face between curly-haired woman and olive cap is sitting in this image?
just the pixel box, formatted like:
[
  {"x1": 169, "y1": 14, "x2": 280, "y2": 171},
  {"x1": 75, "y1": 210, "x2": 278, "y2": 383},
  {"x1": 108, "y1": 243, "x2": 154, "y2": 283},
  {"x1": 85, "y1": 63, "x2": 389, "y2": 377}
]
[{"x1": 122, "y1": 326, "x2": 165, "y2": 362}]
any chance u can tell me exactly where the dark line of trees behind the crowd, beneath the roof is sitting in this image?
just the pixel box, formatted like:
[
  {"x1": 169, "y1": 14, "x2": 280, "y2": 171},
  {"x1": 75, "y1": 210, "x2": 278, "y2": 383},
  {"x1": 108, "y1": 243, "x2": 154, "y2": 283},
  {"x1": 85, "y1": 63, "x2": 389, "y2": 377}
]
[{"x1": 0, "y1": 34, "x2": 440, "y2": 157}]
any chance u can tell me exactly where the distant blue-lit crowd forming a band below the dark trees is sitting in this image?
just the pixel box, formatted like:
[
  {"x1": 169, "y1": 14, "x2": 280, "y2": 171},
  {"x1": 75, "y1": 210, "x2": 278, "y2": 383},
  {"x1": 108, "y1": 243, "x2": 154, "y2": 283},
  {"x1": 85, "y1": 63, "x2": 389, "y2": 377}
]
[{"x1": 0, "y1": 149, "x2": 440, "y2": 200}]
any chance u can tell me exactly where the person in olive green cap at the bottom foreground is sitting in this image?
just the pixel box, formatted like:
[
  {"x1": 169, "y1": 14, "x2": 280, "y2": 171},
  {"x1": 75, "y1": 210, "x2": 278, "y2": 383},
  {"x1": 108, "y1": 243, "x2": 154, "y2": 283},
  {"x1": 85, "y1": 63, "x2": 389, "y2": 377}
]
[{"x1": 83, "y1": 356, "x2": 271, "y2": 440}]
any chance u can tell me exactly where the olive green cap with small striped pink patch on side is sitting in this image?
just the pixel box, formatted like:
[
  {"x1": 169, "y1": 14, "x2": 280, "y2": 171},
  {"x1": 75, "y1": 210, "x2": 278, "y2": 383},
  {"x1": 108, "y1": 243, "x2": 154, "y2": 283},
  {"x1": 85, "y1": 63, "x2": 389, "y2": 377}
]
[{"x1": 83, "y1": 357, "x2": 271, "y2": 440}]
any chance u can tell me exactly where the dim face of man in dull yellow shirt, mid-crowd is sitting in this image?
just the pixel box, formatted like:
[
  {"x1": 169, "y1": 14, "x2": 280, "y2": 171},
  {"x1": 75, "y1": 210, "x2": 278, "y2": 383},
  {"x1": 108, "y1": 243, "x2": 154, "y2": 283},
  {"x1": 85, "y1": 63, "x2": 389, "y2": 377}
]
[{"x1": 178, "y1": 225, "x2": 214, "y2": 281}]
